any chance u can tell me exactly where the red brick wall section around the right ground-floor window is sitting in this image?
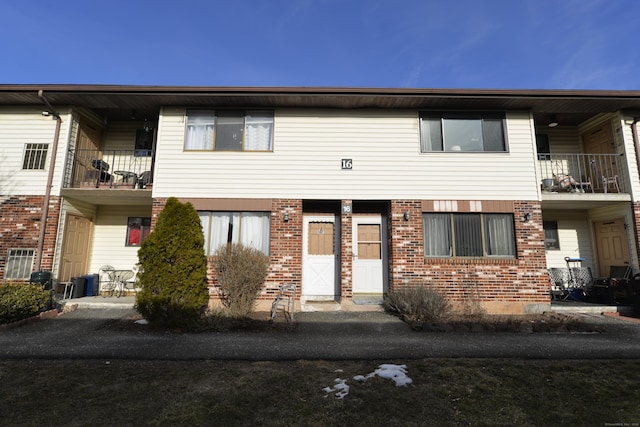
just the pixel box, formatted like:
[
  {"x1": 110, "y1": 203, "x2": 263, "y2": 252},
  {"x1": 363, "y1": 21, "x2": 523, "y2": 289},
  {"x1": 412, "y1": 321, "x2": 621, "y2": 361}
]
[{"x1": 389, "y1": 200, "x2": 549, "y2": 311}]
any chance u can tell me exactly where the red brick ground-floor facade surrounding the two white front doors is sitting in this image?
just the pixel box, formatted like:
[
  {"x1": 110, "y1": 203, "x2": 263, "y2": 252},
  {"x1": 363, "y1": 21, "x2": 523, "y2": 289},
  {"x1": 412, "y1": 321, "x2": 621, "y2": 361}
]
[{"x1": 152, "y1": 199, "x2": 552, "y2": 312}]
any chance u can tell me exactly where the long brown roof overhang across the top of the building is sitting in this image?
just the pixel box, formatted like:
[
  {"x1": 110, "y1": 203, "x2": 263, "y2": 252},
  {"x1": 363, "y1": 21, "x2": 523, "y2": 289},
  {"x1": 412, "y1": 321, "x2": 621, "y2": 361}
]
[{"x1": 0, "y1": 85, "x2": 640, "y2": 125}]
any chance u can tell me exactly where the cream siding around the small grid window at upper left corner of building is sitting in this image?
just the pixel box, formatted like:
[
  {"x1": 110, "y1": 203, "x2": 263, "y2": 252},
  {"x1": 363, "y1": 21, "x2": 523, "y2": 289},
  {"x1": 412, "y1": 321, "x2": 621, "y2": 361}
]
[{"x1": 0, "y1": 108, "x2": 71, "y2": 196}]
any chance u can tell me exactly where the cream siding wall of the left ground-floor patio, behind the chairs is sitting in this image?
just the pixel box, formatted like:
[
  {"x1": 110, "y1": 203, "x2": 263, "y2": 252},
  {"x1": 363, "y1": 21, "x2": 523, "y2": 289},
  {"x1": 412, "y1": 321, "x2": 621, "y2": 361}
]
[{"x1": 89, "y1": 206, "x2": 151, "y2": 273}]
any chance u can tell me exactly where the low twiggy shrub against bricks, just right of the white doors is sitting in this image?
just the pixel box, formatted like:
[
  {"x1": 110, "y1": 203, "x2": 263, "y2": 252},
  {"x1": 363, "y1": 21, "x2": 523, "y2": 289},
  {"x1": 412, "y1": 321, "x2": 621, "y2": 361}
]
[{"x1": 383, "y1": 285, "x2": 452, "y2": 323}]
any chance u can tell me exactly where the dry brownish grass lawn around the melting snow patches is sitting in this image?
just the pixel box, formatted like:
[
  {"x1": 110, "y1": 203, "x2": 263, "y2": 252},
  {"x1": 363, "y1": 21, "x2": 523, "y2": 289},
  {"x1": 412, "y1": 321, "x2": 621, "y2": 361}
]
[{"x1": 0, "y1": 359, "x2": 640, "y2": 426}]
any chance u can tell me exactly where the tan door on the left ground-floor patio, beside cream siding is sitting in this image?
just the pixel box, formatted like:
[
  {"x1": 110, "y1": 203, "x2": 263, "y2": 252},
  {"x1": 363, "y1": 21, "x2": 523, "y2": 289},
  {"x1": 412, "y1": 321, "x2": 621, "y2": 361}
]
[{"x1": 58, "y1": 215, "x2": 91, "y2": 282}]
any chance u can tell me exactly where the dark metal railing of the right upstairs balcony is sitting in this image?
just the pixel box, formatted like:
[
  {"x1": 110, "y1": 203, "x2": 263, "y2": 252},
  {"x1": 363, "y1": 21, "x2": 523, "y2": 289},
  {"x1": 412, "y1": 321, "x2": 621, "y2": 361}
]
[{"x1": 538, "y1": 154, "x2": 628, "y2": 193}]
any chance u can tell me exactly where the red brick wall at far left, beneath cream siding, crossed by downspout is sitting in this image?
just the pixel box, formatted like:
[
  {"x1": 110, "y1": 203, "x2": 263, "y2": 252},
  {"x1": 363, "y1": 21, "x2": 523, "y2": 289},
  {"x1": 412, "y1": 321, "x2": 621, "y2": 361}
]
[{"x1": 0, "y1": 196, "x2": 61, "y2": 279}]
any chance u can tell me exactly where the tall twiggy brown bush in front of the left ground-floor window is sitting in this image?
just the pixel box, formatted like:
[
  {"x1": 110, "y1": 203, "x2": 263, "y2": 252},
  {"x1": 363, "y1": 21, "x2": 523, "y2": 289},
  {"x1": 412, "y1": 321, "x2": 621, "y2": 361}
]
[{"x1": 214, "y1": 243, "x2": 269, "y2": 317}]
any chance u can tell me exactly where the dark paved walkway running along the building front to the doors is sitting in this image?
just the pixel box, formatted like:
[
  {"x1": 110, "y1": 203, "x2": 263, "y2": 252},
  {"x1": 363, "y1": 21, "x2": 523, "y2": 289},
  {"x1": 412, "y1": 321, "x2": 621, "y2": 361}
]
[{"x1": 0, "y1": 304, "x2": 640, "y2": 360}]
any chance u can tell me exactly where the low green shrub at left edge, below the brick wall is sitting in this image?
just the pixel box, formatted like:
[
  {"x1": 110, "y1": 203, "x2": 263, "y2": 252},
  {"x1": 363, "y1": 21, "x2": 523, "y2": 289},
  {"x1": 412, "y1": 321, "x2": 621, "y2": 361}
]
[{"x1": 0, "y1": 283, "x2": 50, "y2": 323}]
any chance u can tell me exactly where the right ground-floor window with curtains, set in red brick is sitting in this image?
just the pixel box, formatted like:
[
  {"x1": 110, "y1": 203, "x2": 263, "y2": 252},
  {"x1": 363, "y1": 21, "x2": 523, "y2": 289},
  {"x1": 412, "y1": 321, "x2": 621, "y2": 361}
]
[{"x1": 422, "y1": 213, "x2": 516, "y2": 257}]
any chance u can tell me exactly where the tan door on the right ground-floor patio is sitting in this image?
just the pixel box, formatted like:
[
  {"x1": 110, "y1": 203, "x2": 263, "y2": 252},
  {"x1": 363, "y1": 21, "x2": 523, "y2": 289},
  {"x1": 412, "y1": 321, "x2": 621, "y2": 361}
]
[{"x1": 594, "y1": 218, "x2": 629, "y2": 276}]
